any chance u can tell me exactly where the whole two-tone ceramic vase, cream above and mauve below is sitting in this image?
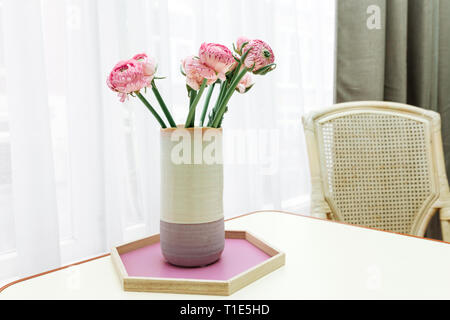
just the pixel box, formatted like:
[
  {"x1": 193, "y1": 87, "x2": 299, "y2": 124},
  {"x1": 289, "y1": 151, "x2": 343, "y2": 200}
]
[{"x1": 160, "y1": 126, "x2": 225, "y2": 267}]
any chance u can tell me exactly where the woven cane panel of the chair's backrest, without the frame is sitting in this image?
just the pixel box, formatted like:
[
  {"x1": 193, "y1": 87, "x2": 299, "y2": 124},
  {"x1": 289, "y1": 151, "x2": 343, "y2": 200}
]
[{"x1": 320, "y1": 113, "x2": 432, "y2": 233}]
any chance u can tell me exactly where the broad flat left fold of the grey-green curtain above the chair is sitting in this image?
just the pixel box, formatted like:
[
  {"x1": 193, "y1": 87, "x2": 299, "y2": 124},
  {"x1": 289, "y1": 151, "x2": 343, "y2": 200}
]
[{"x1": 335, "y1": 0, "x2": 386, "y2": 102}]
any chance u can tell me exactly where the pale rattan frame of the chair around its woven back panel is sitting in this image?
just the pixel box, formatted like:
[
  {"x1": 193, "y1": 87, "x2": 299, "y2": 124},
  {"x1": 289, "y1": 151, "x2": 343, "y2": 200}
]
[{"x1": 302, "y1": 101, "x2": 450, "y2": 242}]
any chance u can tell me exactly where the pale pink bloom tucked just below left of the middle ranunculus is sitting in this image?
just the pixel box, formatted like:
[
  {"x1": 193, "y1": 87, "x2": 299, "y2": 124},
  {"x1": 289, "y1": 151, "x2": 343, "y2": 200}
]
[{"x1": 181, "y1": 56, "x2": 217, "y2": 90}]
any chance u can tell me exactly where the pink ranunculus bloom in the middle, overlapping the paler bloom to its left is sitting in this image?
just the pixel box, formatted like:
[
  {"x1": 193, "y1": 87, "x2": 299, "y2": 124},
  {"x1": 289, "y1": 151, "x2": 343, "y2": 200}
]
[{"x1": 198, "y1": 42, "x2": 235, "y2": 81}]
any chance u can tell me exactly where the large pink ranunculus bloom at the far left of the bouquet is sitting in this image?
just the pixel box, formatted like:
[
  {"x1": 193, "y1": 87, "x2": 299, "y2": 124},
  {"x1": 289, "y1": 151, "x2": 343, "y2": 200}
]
[{"x1": 106, "y1": 59, "x2": 152, "y2": 102}]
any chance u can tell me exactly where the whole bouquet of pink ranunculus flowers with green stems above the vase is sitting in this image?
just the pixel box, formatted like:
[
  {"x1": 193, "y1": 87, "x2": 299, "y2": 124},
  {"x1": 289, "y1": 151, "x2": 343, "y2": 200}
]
[{"x1": 107, "y1": 37, "x2": 276, "y2": 128}]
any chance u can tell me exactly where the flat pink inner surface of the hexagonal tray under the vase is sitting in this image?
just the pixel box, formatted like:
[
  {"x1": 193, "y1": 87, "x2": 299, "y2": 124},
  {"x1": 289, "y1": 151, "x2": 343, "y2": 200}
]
[{"x1": 120, "y1": 239, "x2": 270, "y2": 280}]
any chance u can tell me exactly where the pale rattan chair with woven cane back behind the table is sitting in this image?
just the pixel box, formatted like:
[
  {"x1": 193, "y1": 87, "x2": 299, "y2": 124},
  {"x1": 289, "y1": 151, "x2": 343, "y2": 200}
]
[{"x1": 303, "y1": 101, "x2": 450, "y2": 241}]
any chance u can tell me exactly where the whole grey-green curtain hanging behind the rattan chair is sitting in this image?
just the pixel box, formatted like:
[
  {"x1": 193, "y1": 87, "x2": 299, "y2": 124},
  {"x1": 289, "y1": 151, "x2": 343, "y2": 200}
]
[{"x1": 335, "y1": 0, "x2": 450, "y2": 238}]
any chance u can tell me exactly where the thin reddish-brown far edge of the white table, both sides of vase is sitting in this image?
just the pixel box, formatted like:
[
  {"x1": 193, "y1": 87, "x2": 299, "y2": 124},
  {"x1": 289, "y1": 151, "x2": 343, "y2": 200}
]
[{"x1": 0, "y1": 210, "x2": 450, "y2": 293}]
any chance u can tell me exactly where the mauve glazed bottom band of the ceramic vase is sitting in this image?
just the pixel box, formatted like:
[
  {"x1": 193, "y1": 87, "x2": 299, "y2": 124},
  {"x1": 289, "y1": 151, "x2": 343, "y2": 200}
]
[{"x1": 160, "y1": 219, "x2": 225, "y2": 267}]
